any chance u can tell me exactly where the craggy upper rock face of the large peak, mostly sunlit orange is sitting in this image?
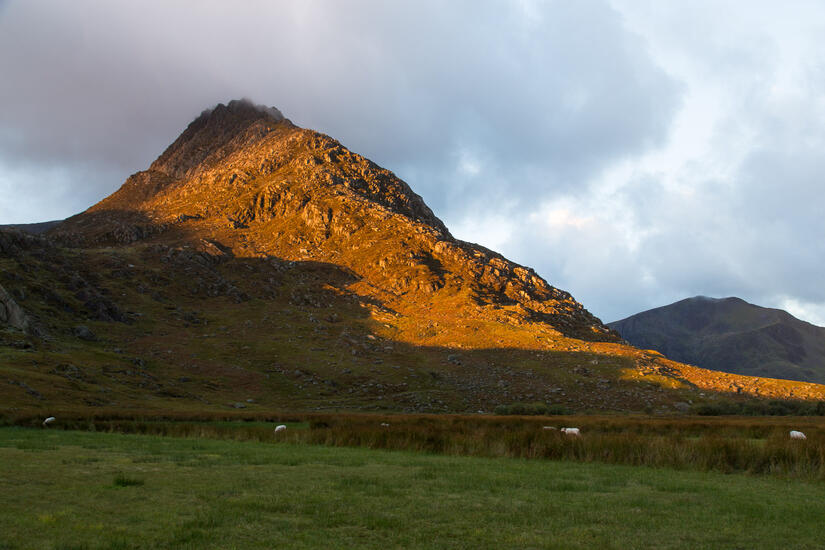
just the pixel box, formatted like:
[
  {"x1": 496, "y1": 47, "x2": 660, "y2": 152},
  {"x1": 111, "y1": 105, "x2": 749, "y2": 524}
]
[{"x1": 53, "y1": 101, "x2": 618, "y2": 341}]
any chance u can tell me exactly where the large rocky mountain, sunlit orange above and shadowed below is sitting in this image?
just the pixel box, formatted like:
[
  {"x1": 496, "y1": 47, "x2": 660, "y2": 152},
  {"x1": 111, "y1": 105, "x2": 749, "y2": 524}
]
[{"x1": 0, "y1": 101, "x2": 825, "y2": 414}]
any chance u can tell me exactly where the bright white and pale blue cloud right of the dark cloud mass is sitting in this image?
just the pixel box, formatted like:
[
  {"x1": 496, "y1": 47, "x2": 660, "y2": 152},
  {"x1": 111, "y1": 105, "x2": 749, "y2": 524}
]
[{"x1": 490, "y1": 1, "x2": 825, "y2": 324}]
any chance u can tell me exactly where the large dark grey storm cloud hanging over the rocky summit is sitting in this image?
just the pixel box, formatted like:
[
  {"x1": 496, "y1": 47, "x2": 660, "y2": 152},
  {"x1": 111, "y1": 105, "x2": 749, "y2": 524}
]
[{"x1": 0, "y1": 1, "x2": 676, "y2": 221}]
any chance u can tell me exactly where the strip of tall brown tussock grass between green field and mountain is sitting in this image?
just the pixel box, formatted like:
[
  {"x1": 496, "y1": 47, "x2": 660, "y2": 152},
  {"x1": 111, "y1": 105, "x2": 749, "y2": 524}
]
[{"x1": 8, "y1": 414, "x2": 825, "y2": 479}]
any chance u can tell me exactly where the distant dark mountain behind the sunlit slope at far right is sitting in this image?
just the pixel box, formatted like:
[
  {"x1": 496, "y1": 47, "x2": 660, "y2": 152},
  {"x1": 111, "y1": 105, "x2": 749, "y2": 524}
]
[{"x1": 608, "y1": 296, "x2": 825, "y2": 384}]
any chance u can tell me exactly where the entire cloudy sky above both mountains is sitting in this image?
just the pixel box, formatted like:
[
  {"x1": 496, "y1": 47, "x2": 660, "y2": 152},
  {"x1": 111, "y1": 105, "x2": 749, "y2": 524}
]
[{"x1": 0, "y1": 0, "x2": 825, "y2": 325}]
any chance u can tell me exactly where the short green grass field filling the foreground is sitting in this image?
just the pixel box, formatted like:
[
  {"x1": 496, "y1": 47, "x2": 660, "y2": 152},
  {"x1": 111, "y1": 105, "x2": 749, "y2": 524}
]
[{"x1": 0, "y1": 428, "x2": 825, "y2": 550}]
